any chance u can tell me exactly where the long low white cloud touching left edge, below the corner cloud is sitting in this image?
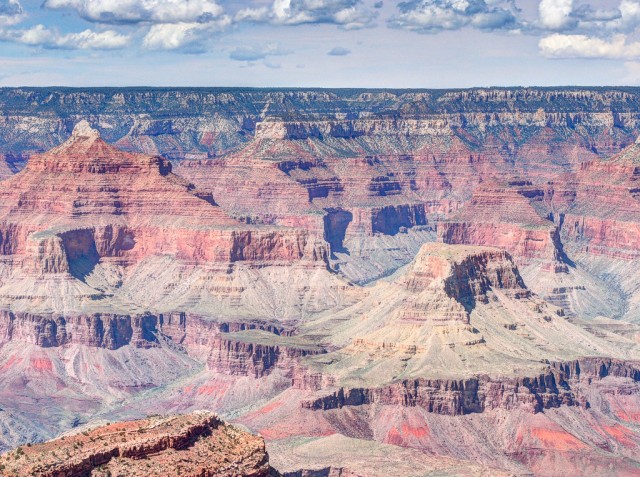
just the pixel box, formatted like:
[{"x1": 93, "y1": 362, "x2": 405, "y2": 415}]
[{"x1": 0, "y1": 25, "x2": 130, "y2": 50}]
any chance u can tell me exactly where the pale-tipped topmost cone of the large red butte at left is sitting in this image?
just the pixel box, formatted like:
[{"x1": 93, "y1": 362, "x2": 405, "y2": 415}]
[{"x1": 26, "y1": 120, "x2": 171, "y2": 176}]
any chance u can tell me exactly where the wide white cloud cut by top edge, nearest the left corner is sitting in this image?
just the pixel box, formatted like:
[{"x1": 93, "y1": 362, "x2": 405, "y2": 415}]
[{"x1": 44, "y1": 0, "x2": 224, "y2": 23}]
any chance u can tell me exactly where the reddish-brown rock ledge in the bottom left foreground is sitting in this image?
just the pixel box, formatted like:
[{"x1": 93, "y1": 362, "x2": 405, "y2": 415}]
[{"x1": 0, "y1": 411, "x2": 270, "y2": 477}]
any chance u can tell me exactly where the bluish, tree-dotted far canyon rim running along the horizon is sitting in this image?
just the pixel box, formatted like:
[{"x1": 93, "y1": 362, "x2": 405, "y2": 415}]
[{"x1": 0, "y1": 88, "x2": 639, "y2": 159}]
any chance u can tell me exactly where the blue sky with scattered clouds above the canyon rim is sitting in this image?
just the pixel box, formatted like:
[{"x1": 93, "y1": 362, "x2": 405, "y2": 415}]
[{"x1": 0, "y1": 0, "x2": 640, "y2": 88}]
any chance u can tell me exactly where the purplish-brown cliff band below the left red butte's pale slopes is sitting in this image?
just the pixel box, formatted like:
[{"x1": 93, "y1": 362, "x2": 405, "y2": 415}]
[{"x1": 0, "y1": 310, "x2": 325, "y2": 379}]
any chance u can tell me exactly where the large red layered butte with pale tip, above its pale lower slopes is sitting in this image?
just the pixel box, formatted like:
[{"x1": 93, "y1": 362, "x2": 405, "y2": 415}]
[{"x1": 0, "y1": 123, "x2": 326, "y2": 274}]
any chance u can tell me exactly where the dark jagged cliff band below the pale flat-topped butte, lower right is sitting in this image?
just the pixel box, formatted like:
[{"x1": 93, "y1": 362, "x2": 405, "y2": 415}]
[{"x1": 300, "y1": 358, "x2": 640, "y2": 416}]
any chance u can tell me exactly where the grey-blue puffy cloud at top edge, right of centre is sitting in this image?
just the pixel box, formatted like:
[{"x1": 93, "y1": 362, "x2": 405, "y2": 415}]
[{"x1": 389, "y1": 0, "x2": 519, "y2": 33}]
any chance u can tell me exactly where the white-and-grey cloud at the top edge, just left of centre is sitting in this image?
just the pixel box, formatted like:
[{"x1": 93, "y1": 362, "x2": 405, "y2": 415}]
[{"x1": 235, "y1": 0, "x2": 377, "y2": 30}]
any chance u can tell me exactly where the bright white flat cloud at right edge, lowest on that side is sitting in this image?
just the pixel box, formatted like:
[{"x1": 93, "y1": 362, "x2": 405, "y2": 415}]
[{"x1": 538, "y1": 33, "x2": 640, "y2": 59}]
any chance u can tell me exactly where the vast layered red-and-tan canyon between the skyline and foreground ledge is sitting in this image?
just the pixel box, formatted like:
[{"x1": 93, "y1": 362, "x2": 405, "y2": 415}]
[{"x1": 0, "y1": 88, "x2": 640, "y2": 476}]
